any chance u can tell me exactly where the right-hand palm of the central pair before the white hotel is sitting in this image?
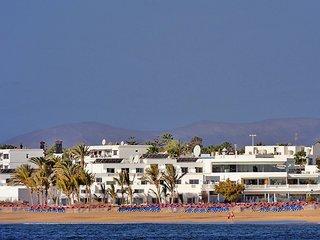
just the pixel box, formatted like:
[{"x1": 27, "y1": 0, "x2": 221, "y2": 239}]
[{"x1": 162, "y1": 164, "x2": 186, "y2": 203}]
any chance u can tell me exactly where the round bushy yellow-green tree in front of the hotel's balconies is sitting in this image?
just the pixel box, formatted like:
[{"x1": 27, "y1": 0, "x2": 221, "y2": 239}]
[{"x1": 214, "y1": 179, "x2": 245, "y2": 202}]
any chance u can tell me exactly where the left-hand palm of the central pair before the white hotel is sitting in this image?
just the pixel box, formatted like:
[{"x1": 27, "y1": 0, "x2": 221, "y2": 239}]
[{"x1": 141, "y1": 164, "x2": 162, "y2": 203}]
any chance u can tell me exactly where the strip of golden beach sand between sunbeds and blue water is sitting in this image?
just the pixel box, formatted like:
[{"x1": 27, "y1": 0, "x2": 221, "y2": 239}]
[{"x1": 0, "y1": 209, "x2": 320, "y2": 223}]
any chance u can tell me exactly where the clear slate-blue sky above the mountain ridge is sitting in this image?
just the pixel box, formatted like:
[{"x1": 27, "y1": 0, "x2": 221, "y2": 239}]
[{"x1": 0, "y1": 0, "x2": 320, "y2": 140}]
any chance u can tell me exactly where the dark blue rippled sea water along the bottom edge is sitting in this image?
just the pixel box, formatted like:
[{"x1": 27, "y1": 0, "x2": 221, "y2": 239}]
[{"x1": 0, "y1": 223, "x2": 320, "y2": 240}]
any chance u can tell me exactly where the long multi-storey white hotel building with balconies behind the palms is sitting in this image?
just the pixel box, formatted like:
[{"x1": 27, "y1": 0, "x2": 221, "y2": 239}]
[{"x1": 82, "y1": 143, "x2": 320, "y2": 203}]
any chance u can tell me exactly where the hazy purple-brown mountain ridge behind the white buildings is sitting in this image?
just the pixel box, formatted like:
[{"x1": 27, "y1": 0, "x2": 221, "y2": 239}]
[{"x1": 4, "y1": 118, "x2": 320, "y2": 147}]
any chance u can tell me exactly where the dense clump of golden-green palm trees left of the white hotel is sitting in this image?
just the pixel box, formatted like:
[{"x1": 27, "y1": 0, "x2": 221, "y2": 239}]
[{"x1": 10, "y1": 152, "x2": 94, "y2": 204}]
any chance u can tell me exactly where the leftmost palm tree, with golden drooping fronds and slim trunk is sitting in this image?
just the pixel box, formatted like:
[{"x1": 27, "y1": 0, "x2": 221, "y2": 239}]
[{"x1": 10, "y1": 164, "x2": 34, "y2": 205}]
